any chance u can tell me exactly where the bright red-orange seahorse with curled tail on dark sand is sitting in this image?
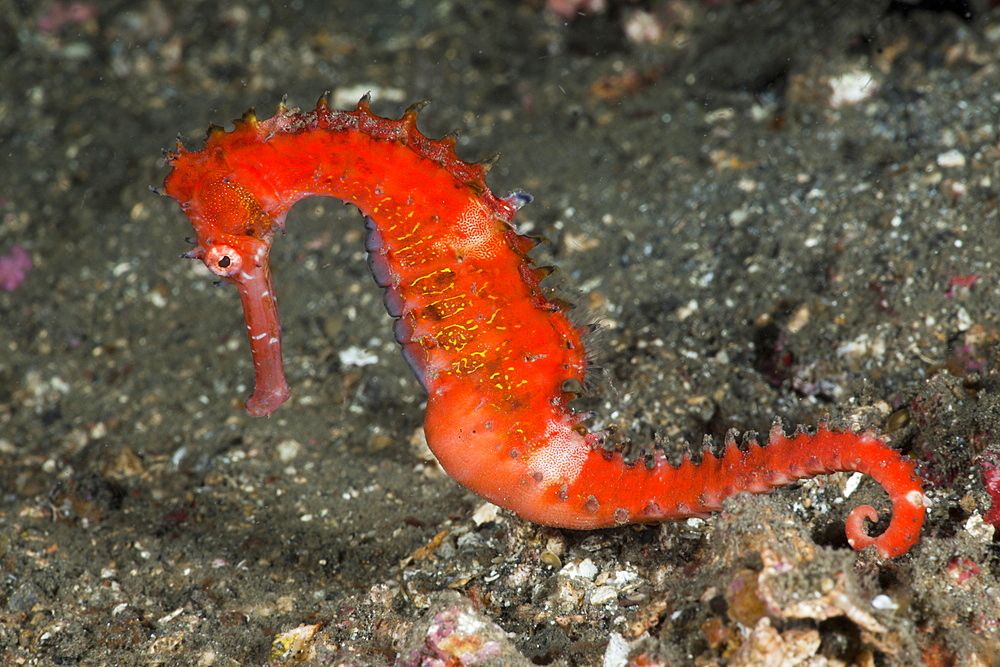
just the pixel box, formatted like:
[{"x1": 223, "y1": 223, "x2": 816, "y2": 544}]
[{"x1": 158, "y1": 97, "x2": 929, "y2": 557}]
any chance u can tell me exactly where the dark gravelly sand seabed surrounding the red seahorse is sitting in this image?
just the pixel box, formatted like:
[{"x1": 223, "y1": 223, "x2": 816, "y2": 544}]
[{"x1": 0, "y1": 0, "x2": 1000, "y2": 666}]
